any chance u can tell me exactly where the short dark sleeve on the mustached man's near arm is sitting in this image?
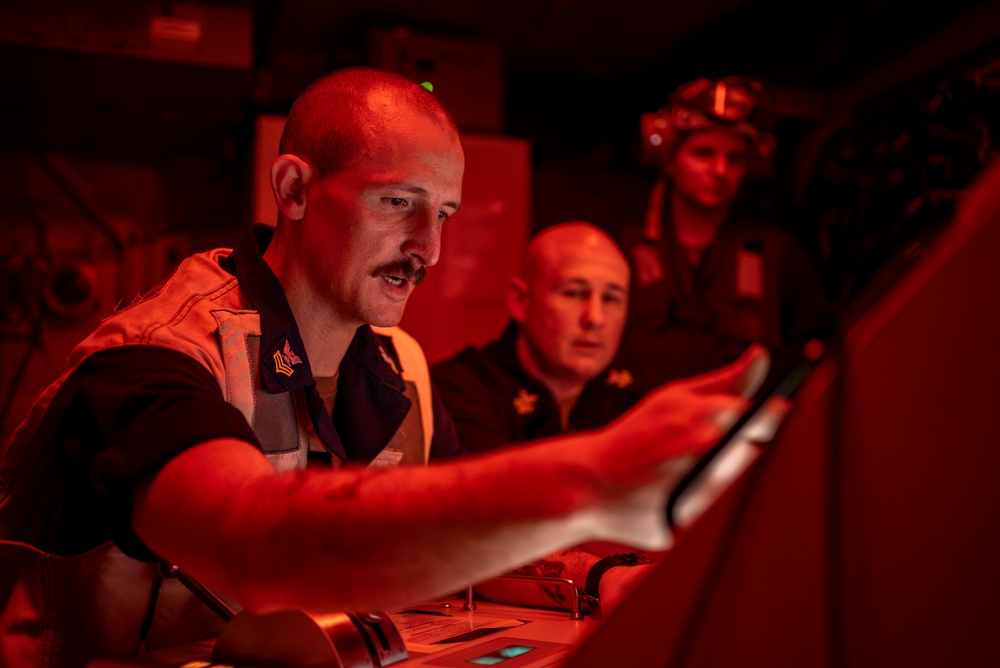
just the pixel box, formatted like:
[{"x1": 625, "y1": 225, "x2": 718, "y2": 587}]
[{"x1": 53, "y1": 346, "x2": 260, "y2": 560}]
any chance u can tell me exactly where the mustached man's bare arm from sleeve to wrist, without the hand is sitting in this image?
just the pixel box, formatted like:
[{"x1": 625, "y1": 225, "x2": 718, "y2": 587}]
[{"x1": 135, "y1": 434, "x2": 612, "y2": 610}]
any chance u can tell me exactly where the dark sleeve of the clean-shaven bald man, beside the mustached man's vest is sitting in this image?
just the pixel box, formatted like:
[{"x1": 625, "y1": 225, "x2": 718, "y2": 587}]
[{"x1": 431, "y1": 359, "x2": 512, "y2": 453}]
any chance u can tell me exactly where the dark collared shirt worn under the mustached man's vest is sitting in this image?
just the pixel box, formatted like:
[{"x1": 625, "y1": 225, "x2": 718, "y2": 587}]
[{"x1": 23, "y1": 226, "x2": 458, "y2": 560}]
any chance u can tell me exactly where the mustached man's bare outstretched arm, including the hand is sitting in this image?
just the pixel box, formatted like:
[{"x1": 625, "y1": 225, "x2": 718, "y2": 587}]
[{"x1": 133, "y1": 344, "x2": 762, "y2": 612}]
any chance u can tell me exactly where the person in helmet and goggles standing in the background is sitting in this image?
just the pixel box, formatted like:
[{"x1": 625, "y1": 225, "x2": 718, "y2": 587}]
[{"x1": 623, "y1": 77, "x2": 833, "y2": 386}]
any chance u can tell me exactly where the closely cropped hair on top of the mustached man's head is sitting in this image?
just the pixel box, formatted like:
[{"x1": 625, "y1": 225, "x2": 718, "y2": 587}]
[{"x1": 279, "y1": 67, "x2": 458, "y2": 175}]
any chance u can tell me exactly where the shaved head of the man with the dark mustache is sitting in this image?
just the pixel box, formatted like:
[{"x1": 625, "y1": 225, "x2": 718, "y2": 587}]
[{"x1": 264, "y1": 68, "x2": 465, "y2": 352}]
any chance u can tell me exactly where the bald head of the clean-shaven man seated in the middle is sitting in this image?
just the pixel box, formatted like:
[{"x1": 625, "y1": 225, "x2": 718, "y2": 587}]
[{"x1": 508, "y1": 222, "x2": 629, "y2": 398}]
